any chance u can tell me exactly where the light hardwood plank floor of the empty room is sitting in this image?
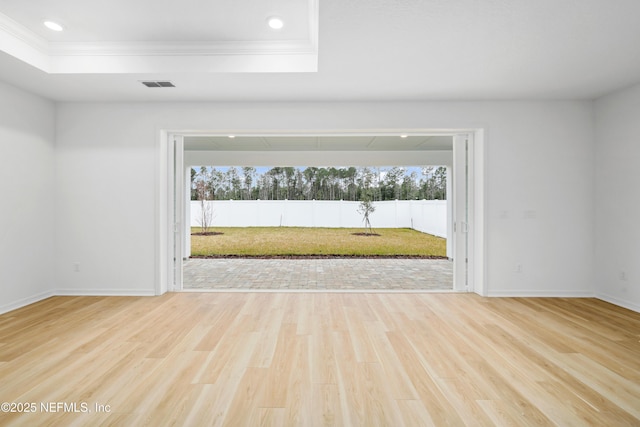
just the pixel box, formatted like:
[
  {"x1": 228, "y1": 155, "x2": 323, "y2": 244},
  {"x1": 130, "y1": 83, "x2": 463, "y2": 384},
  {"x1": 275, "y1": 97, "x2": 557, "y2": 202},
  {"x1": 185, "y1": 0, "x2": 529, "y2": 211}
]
[{"x1": 0, "y1": 293, "x2": 640, "y2": 426}]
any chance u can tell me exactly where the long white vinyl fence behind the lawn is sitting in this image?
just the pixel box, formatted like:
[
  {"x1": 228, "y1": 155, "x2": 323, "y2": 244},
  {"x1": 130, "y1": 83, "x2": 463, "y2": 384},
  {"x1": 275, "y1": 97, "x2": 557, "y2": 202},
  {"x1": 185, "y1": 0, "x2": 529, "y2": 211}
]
[{"x1": 190, "y1": 200, "x2": 447, "y2": 238}]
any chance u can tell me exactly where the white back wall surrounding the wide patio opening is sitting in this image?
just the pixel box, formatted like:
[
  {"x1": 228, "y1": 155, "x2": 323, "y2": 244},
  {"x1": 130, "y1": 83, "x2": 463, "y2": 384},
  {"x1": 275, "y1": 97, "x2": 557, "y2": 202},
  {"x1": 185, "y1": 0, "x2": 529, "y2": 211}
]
[{"x1": 56, "y1": 102, "x2": 595, "y2": 295}]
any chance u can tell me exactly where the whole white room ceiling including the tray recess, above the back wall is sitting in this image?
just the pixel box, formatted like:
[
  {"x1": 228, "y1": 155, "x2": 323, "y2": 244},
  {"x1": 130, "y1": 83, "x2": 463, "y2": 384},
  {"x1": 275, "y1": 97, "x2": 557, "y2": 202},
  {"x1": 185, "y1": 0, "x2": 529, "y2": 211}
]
[{"x1": 0, "y1": 0, "x2": 640, "y2": 101}]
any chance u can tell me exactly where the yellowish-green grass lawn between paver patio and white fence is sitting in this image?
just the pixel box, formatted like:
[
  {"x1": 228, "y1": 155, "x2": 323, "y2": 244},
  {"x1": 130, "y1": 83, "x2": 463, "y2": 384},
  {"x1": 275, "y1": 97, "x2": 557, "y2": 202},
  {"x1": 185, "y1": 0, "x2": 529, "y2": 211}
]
[{"x1": 191, "y1": 227, "x2": 446, "y2": 257}]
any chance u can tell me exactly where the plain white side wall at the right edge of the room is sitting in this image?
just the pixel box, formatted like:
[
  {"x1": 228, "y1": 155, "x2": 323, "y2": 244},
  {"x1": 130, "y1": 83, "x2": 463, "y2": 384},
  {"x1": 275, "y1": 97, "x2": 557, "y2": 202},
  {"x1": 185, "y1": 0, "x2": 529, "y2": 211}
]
[{"x1": 595, "y1": 85, "x2": 640, "y2": 311}]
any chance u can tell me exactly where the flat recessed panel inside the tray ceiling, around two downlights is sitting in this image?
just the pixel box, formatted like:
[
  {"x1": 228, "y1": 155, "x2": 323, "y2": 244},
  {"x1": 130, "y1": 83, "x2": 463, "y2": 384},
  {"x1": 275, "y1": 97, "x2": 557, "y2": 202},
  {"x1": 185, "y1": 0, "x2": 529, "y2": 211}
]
[{"x1": 0, "y1": 0, "x2": 310, "y2": 42}]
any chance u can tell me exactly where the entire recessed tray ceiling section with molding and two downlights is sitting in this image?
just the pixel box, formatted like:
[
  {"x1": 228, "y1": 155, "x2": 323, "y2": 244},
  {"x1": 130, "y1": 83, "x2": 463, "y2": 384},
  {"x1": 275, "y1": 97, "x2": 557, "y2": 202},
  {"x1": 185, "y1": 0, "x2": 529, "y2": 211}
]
[{"x1": 0, "y1": 0, "x2": 318, "y2": 74}]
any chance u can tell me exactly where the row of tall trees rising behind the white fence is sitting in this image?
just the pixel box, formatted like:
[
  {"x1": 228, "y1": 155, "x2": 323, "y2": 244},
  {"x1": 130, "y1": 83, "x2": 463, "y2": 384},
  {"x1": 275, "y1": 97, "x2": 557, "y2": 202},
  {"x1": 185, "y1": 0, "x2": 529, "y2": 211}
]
[{"x1": 191, "y1": 166, "x2": 447, "y2": 201}]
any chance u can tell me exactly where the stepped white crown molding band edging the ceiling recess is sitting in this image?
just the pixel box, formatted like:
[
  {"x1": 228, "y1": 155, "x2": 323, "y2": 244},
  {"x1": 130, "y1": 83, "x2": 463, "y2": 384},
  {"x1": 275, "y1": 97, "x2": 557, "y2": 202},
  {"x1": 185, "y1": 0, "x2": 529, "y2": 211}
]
[{"x1": 0, "y1": 0, "x2": 319, "y2": 74}]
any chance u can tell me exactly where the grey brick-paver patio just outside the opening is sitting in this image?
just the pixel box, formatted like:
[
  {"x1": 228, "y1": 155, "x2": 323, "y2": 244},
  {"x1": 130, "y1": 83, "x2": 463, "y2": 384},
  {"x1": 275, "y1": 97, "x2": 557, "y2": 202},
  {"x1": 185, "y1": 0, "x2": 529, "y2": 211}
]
[{"x1": 183, "y1": 258, "x2": 453, "y2": 291}]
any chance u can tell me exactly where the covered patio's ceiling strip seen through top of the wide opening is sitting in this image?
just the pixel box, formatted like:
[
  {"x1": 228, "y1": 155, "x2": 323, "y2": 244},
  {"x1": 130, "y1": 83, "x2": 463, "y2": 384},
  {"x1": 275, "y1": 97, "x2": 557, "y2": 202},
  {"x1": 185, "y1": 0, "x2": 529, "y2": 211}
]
[{"x1": 184, "y1": 135, "x2": 453, "y2": 151}]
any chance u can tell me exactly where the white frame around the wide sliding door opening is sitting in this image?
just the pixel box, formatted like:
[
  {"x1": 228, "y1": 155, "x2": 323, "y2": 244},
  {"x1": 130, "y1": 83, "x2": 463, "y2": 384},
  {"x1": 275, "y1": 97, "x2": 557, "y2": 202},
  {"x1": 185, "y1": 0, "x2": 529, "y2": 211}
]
[{"x1": 156, "y1": 128, "x2": 488, "y2": 296}]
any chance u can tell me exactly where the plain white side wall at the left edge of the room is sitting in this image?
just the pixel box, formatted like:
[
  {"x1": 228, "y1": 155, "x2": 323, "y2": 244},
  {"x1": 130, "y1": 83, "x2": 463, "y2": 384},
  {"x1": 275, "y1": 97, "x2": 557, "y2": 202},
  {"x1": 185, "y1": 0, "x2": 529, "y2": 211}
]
[{"x1": 0, "y1": 82, "x2": 55, "y2": 313}]
